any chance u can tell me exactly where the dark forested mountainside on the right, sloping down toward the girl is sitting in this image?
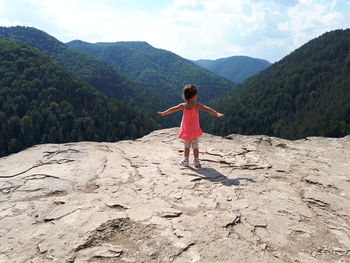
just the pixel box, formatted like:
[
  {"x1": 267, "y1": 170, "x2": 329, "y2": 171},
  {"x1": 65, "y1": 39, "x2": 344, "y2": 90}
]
[{"x1": 205, "y1": 29, "x2": 350, "y2": 139}]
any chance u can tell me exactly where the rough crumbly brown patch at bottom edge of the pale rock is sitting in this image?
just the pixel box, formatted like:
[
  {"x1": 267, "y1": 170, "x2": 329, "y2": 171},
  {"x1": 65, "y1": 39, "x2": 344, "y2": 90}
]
[{"x1": 72, "y1": 218, "x2": 179, "y2": 263}]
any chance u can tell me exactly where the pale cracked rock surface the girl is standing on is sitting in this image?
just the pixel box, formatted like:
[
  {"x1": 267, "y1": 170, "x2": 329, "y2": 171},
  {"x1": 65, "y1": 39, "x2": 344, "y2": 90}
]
[{"x1": 0, "y1": 128, "x2": 350, "y2": 263}]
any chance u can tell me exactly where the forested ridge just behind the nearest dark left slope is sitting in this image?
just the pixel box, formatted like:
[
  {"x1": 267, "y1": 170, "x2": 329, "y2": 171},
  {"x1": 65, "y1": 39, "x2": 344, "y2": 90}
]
[{"x1": 0, "y1": 26, "x2": 168, "y2": 120}]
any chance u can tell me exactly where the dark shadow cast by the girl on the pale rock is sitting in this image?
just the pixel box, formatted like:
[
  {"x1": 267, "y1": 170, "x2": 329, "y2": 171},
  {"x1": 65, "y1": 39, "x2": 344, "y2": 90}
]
[{"x1": 184, "y1": 167, "x2": 256, "y2": 186}]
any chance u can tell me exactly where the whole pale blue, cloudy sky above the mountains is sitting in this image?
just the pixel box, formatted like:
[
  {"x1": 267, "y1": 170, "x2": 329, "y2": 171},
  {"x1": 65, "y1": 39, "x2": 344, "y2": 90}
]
[{"x1": 0, "y1": 0, "x2": 350, "y2": 62}]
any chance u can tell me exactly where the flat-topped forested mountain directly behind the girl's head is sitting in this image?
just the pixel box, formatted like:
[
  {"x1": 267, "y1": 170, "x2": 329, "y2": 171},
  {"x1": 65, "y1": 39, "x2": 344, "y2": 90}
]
[{"x1": 67, "y1": 40, "x2": 234, "y2": 103}]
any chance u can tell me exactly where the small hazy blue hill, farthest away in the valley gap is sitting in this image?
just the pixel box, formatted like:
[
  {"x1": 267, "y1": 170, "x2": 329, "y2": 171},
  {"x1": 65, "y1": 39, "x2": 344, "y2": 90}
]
[{"x1": 193, "y1": 56, "x2": 271, "y2": 83}]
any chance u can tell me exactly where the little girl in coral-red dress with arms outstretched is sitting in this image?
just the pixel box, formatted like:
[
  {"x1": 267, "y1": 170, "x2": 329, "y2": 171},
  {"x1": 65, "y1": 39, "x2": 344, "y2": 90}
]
[{"x1": 157, "y1": 84, "x2": 224, "y2": 168}]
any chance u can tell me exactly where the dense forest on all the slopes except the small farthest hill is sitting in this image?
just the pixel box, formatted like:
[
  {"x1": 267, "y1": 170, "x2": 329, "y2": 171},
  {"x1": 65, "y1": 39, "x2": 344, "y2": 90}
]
[{"x1": 0, "y1": 27, "x2": 350, "y2": 159}]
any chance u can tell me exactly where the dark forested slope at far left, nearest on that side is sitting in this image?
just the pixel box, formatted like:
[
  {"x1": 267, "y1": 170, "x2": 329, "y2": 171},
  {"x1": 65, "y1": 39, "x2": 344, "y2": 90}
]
[{"x1": 0, "y1": 38, "x2": 158, "y2": 156}]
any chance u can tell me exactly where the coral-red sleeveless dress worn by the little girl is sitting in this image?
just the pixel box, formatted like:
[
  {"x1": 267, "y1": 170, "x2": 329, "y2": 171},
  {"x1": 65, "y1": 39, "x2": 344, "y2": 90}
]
[{"x1": 179, "y1": 105, "x2": 202, "y2": 141}]
